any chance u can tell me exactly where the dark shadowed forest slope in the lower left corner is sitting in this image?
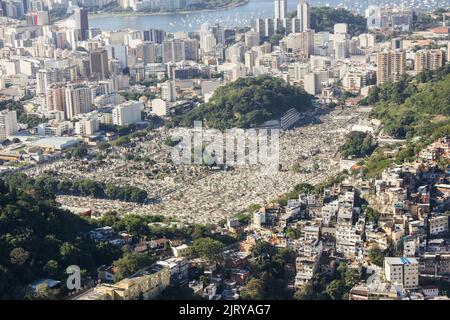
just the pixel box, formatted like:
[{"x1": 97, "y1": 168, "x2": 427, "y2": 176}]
[{"x1": 0, "y1": 180, "x2": 121, "y2": 299}]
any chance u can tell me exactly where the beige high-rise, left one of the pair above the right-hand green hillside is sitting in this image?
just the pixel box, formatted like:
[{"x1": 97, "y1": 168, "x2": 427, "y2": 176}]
[{"x1": 377, "y1": 50, "x2": 406, "y2": 85}]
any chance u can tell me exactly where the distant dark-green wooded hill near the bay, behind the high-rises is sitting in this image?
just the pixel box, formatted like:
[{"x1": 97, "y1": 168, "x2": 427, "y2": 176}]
[{"x1": 290, "y1": 7, "x2": 367, "y2": 36}]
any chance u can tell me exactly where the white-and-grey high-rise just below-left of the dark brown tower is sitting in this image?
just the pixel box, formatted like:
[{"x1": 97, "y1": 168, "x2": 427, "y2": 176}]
[{"x1": 64, "y1": 85, "x2": 92, "y2": 119}]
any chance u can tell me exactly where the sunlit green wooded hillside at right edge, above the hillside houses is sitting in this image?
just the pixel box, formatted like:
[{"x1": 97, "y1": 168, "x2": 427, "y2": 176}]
[{"x1": 363, "y1": 65, "x2": 450, "y2": 138}]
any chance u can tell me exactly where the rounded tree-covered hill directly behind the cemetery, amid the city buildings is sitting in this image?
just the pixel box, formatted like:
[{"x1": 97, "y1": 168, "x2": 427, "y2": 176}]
[{"x1": 181, "y1": 76, "x2": 312, "y2": 129}]
